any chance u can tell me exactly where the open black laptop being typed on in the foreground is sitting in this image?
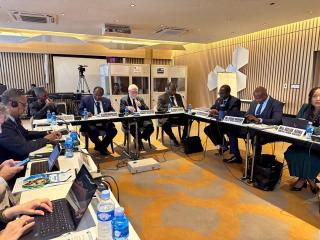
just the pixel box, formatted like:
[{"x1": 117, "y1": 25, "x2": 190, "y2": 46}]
[{"x1": 21, "y1": 165, "x2": 97, "y2": 239}]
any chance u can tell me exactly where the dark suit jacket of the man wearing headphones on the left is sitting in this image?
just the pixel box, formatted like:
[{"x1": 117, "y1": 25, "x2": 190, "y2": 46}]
[{"x1": 0, "y1": 118, "x2": 49, "y2": 163}]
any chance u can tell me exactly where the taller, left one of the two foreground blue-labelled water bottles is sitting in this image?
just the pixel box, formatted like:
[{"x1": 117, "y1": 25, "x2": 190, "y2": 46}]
[{"x1": 97, "y1": 190, "x2": 114, "y2": 240}]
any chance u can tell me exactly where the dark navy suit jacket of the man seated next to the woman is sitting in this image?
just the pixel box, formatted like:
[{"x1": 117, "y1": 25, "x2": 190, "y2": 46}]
[{"x1": 246, "y1": 97, "x2": 283, "y2": 125}]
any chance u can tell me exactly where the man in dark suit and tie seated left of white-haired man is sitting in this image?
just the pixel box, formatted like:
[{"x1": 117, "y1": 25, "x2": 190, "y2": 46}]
[{"x1": 79, "y1": 87, "x2": 117, "y2": 155}]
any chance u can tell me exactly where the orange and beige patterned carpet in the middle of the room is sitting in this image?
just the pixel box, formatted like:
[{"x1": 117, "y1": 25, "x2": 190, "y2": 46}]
[{"x1": 90, "y1": 124, "x2": 320, "y2": 240}]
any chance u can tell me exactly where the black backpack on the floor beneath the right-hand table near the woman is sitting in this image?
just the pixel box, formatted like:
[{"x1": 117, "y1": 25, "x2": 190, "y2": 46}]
[{"x1": 253, "y1": 154, "x2": 283, "y2": 191}]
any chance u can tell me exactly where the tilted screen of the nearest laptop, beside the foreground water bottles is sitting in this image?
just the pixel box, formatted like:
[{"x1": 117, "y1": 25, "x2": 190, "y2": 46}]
[{"x1": 66, "y1": 165, "x2": 97, "y2": 228}]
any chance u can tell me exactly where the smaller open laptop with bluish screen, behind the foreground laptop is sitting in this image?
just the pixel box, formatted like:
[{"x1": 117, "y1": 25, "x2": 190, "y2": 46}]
[{"x1": 30, "y1": 144, "x2": 61, "y2": 175}]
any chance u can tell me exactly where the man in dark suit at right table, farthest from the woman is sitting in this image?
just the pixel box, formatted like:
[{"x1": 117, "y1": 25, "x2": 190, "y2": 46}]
[{"x1": 204, "y1": 85, "x2": 241, "y2": 154}]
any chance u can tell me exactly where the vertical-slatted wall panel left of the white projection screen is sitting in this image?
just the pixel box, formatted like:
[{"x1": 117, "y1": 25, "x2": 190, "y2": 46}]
[{"x1": 0, "y1": 52, "x2": 54, "y2": 92}]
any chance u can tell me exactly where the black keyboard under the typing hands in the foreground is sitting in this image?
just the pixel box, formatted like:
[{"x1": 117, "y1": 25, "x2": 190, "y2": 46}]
[{"x1": 36, "y1": 199, "x2": 74, "y2": 237}]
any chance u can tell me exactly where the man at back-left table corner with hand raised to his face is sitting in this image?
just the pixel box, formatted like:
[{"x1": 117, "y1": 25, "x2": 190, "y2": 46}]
[{"x1": 29, "y1": 87, "x2": 58, "y2": 119}]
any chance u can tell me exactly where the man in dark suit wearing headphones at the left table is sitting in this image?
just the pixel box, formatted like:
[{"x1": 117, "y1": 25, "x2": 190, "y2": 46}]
[{"x1": 0, "y1": 89, "x2": 61, "y2": 162}]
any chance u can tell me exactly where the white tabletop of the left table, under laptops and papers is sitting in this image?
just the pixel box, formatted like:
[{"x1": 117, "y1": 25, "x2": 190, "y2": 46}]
[{"x1": 20, "y1": 126, "x2": 140, "y2": 240}]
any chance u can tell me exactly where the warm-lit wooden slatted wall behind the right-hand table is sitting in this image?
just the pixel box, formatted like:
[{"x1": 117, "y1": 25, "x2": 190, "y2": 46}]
[{"x1": 174, "y1": 18, "x2": 320, "y2": 114}]
